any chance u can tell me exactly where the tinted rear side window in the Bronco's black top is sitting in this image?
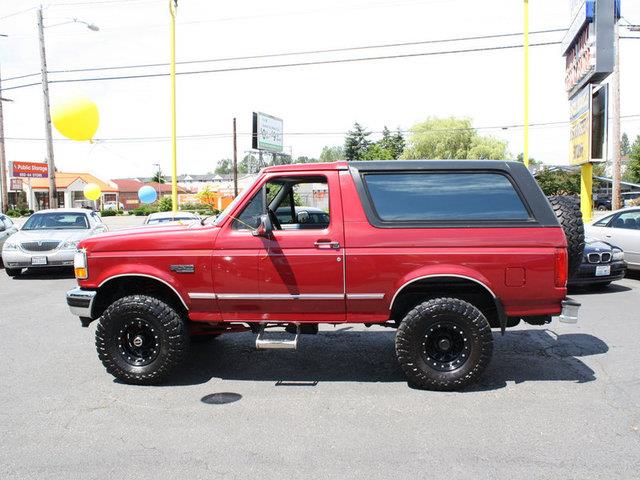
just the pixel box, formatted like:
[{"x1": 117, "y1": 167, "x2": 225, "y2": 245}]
[{"x1": 364, "y1": 172, "x2": 530, "y2": 222}]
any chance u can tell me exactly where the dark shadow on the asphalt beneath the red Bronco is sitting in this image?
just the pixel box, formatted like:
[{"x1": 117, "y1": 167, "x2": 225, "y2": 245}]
[{"x1": 158, "y1": 329, "x2": 609, "y2": 392}]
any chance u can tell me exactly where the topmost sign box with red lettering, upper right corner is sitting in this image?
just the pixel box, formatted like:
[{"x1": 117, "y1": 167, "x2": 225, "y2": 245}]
[{"x1": 562, "y1": 0, "x2": 619, "y2": 98}]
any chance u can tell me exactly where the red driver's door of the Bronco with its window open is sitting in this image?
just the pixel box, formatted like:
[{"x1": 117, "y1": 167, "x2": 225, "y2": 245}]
[{"x1": 258, "y1": 171, "x2": 345, "y2": 322}]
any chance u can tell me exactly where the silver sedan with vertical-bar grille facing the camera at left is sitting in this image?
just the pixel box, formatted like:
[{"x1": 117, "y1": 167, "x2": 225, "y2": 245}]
[{"x1": 2, "y1": 208, "x2": 108, "y2": 277}]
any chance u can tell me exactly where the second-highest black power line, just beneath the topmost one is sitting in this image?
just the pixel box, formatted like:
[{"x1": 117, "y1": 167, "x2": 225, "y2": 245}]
[{"x1": 3, "y1": 42, "x2": 562, "y2": 90}]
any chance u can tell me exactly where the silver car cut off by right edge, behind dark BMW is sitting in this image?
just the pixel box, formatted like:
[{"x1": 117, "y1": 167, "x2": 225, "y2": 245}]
[{"x1": 585, "y1": 207, "x2": 640, "y2": 270}]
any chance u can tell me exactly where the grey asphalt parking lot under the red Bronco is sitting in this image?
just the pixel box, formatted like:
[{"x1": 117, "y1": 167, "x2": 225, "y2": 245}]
[{"x1": 0, "y1": 219, "x2": 640, "y2": 479}]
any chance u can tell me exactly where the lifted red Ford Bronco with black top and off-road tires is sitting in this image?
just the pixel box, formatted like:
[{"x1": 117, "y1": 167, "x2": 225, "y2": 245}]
[{"x1": 67, "y1": 160, "x2": 584, "y2": 390}]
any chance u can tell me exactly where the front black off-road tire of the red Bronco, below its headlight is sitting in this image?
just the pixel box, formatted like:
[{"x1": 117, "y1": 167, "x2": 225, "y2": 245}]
[{"x1": 96, "y1": 295, "x2": 189, "y2": 385}]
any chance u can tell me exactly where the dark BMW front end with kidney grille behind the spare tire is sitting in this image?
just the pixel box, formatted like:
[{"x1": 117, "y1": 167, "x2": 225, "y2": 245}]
[{"x1": 568, "y1": 237, "x2": 627, "y2": 288}]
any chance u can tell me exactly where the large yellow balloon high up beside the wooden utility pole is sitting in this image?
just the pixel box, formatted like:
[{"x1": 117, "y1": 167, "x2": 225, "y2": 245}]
[{"x1": 51, "y1": 95, "x2": 100, "y2": 142}]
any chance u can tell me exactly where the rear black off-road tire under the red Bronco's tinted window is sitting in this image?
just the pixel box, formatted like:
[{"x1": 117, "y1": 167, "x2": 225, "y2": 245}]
[{"x1": 396, "y1": 298, "x2": 493, "y2": 390}]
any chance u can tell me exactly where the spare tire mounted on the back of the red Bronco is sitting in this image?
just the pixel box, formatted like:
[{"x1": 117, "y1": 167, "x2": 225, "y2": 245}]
[{"x1": 547, "y1": 195, "x2": 584, "y2": 277}]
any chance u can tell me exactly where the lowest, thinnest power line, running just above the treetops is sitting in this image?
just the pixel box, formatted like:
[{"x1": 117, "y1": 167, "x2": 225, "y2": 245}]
[{"x1": 5, "y1": 113, "x2": 640, "y2": 143}]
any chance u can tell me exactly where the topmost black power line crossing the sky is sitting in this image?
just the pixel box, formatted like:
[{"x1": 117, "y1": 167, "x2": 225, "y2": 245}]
[{"x1": 3, "y1": 28, "x2": 567, "y2": 81}]
